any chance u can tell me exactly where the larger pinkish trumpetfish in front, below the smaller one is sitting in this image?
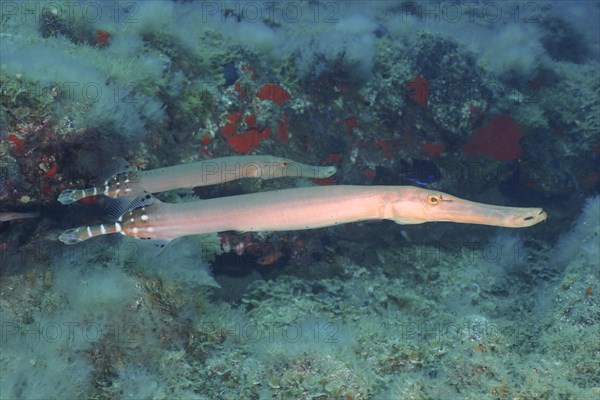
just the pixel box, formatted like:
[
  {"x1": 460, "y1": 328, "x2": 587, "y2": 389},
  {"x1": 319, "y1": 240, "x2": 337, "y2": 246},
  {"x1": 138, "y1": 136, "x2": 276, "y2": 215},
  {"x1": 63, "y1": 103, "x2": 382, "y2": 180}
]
[{"x1": 59, "y1": 185, "x2": 547, "y2": 244}]
